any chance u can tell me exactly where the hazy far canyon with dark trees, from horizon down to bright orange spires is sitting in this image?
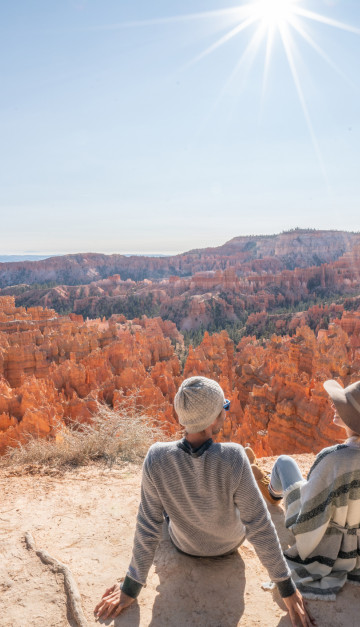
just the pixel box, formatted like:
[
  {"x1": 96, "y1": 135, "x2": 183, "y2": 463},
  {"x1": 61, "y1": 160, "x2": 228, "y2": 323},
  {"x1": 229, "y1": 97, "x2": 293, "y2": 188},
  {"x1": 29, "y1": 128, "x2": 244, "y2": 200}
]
[{"x1": 0, "y1": 230, "x2": 360, "y2": 340}]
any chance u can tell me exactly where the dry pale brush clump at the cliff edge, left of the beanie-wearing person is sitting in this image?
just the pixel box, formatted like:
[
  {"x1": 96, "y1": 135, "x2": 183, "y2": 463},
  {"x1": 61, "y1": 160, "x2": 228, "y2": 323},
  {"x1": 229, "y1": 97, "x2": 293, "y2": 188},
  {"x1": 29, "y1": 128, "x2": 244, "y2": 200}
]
[{"x1": 0, "y1": 405, "x2": 165, "y2": 468}]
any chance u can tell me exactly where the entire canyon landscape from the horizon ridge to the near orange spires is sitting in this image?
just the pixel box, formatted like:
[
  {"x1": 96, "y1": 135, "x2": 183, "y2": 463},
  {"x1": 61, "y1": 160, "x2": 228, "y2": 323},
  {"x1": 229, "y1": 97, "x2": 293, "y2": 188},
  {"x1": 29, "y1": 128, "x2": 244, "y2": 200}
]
[{"x1": 0, "y1": 229, "x2": 360, "y2": 456}]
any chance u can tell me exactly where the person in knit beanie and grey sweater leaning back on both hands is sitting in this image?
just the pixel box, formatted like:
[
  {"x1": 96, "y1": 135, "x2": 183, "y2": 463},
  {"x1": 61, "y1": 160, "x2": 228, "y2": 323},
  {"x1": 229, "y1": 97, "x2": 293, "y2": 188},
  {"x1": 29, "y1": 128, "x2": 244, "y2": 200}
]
[{"x1": 95, "y1": 377, "x2": 315, "y2": 627}]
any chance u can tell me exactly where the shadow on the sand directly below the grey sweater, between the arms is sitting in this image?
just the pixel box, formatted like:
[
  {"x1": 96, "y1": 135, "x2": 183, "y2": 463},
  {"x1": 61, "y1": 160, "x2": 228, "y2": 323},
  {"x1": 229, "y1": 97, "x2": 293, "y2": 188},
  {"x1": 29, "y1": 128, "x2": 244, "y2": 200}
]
[{"x1": 148, "y1": 529, "x2": 245, "y2": 627}]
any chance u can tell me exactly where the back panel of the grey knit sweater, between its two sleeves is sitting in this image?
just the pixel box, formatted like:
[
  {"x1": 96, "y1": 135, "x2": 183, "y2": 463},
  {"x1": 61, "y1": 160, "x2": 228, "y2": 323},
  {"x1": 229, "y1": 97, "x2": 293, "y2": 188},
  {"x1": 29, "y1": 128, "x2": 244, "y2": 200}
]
[{"x1": 145, "y1": 439, "x2": 248, "y2": 556}]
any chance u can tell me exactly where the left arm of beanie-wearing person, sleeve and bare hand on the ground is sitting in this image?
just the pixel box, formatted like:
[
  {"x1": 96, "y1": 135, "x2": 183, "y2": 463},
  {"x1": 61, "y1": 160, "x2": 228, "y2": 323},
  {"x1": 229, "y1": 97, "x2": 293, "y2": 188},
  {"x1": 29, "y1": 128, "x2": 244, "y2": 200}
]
[{"x1": 95, "y1": 449, "x2": 164, "y2": 617}]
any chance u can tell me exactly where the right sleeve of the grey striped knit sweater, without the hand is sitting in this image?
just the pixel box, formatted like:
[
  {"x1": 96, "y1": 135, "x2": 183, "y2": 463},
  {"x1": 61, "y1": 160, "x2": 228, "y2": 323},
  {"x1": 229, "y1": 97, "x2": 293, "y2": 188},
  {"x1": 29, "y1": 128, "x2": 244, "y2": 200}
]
[{"x1": 234, "y1": 455, "x2": 295, "y2": 597}]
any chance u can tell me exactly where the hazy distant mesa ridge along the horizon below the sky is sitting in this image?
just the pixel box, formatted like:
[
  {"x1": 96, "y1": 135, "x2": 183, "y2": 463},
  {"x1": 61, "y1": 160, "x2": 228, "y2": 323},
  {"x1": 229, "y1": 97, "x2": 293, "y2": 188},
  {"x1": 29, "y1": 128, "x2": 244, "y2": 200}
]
[{"x1": 0, "y1": 229, "x2": 360, "y2": 288}]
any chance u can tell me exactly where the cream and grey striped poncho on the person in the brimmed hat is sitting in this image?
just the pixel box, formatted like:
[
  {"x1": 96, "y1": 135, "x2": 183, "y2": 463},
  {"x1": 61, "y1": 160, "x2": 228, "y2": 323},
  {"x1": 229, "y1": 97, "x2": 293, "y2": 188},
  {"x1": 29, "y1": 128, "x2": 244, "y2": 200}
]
[{"x1": 284, "y1": 444, "x2": 360, "y2": 601}]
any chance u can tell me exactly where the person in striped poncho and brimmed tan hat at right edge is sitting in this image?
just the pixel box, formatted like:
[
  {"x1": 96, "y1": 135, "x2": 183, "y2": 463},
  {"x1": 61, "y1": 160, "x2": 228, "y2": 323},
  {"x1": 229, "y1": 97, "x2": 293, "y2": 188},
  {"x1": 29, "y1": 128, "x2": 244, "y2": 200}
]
[{"x1": 255, "y1": 380, "x2": 360, "y2": 600}]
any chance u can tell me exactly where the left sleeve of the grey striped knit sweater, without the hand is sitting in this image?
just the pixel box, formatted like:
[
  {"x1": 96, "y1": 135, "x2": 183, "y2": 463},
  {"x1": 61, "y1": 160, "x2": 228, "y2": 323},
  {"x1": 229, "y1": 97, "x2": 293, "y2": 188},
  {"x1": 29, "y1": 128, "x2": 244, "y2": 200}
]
[{"x1": 124, "y1": 449, "x2": 164, "y2": 596}]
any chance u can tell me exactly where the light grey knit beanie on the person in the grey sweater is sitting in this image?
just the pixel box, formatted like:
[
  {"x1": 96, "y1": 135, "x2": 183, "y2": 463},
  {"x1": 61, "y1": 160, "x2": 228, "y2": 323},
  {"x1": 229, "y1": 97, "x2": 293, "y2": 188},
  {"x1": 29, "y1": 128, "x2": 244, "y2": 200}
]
[{"x1": 174, "y1": 377, "x2": 225, "y2": 433}]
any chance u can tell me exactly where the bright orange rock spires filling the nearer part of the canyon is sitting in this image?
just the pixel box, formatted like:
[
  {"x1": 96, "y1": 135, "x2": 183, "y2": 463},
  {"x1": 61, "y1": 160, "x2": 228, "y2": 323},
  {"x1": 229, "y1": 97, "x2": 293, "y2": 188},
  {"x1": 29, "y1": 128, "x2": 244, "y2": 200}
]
[{"x1": 0, "y1": 296, "x2": 360, "y2": 456}]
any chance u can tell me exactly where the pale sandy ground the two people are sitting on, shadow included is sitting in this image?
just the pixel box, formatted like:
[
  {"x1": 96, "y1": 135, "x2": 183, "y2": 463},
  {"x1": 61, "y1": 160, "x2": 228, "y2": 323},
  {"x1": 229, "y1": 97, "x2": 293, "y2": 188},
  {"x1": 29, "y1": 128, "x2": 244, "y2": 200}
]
[{"x1": 0, "y1": 456, "x2": 359, "y2": 627}]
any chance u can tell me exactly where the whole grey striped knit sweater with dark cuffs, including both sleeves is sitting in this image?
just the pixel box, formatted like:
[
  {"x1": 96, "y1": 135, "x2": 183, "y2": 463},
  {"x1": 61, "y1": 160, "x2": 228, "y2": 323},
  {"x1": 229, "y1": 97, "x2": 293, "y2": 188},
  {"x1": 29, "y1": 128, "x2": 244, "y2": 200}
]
[{"x1": 122, "y1": 439, "x2": 295, "y2": 597}]
